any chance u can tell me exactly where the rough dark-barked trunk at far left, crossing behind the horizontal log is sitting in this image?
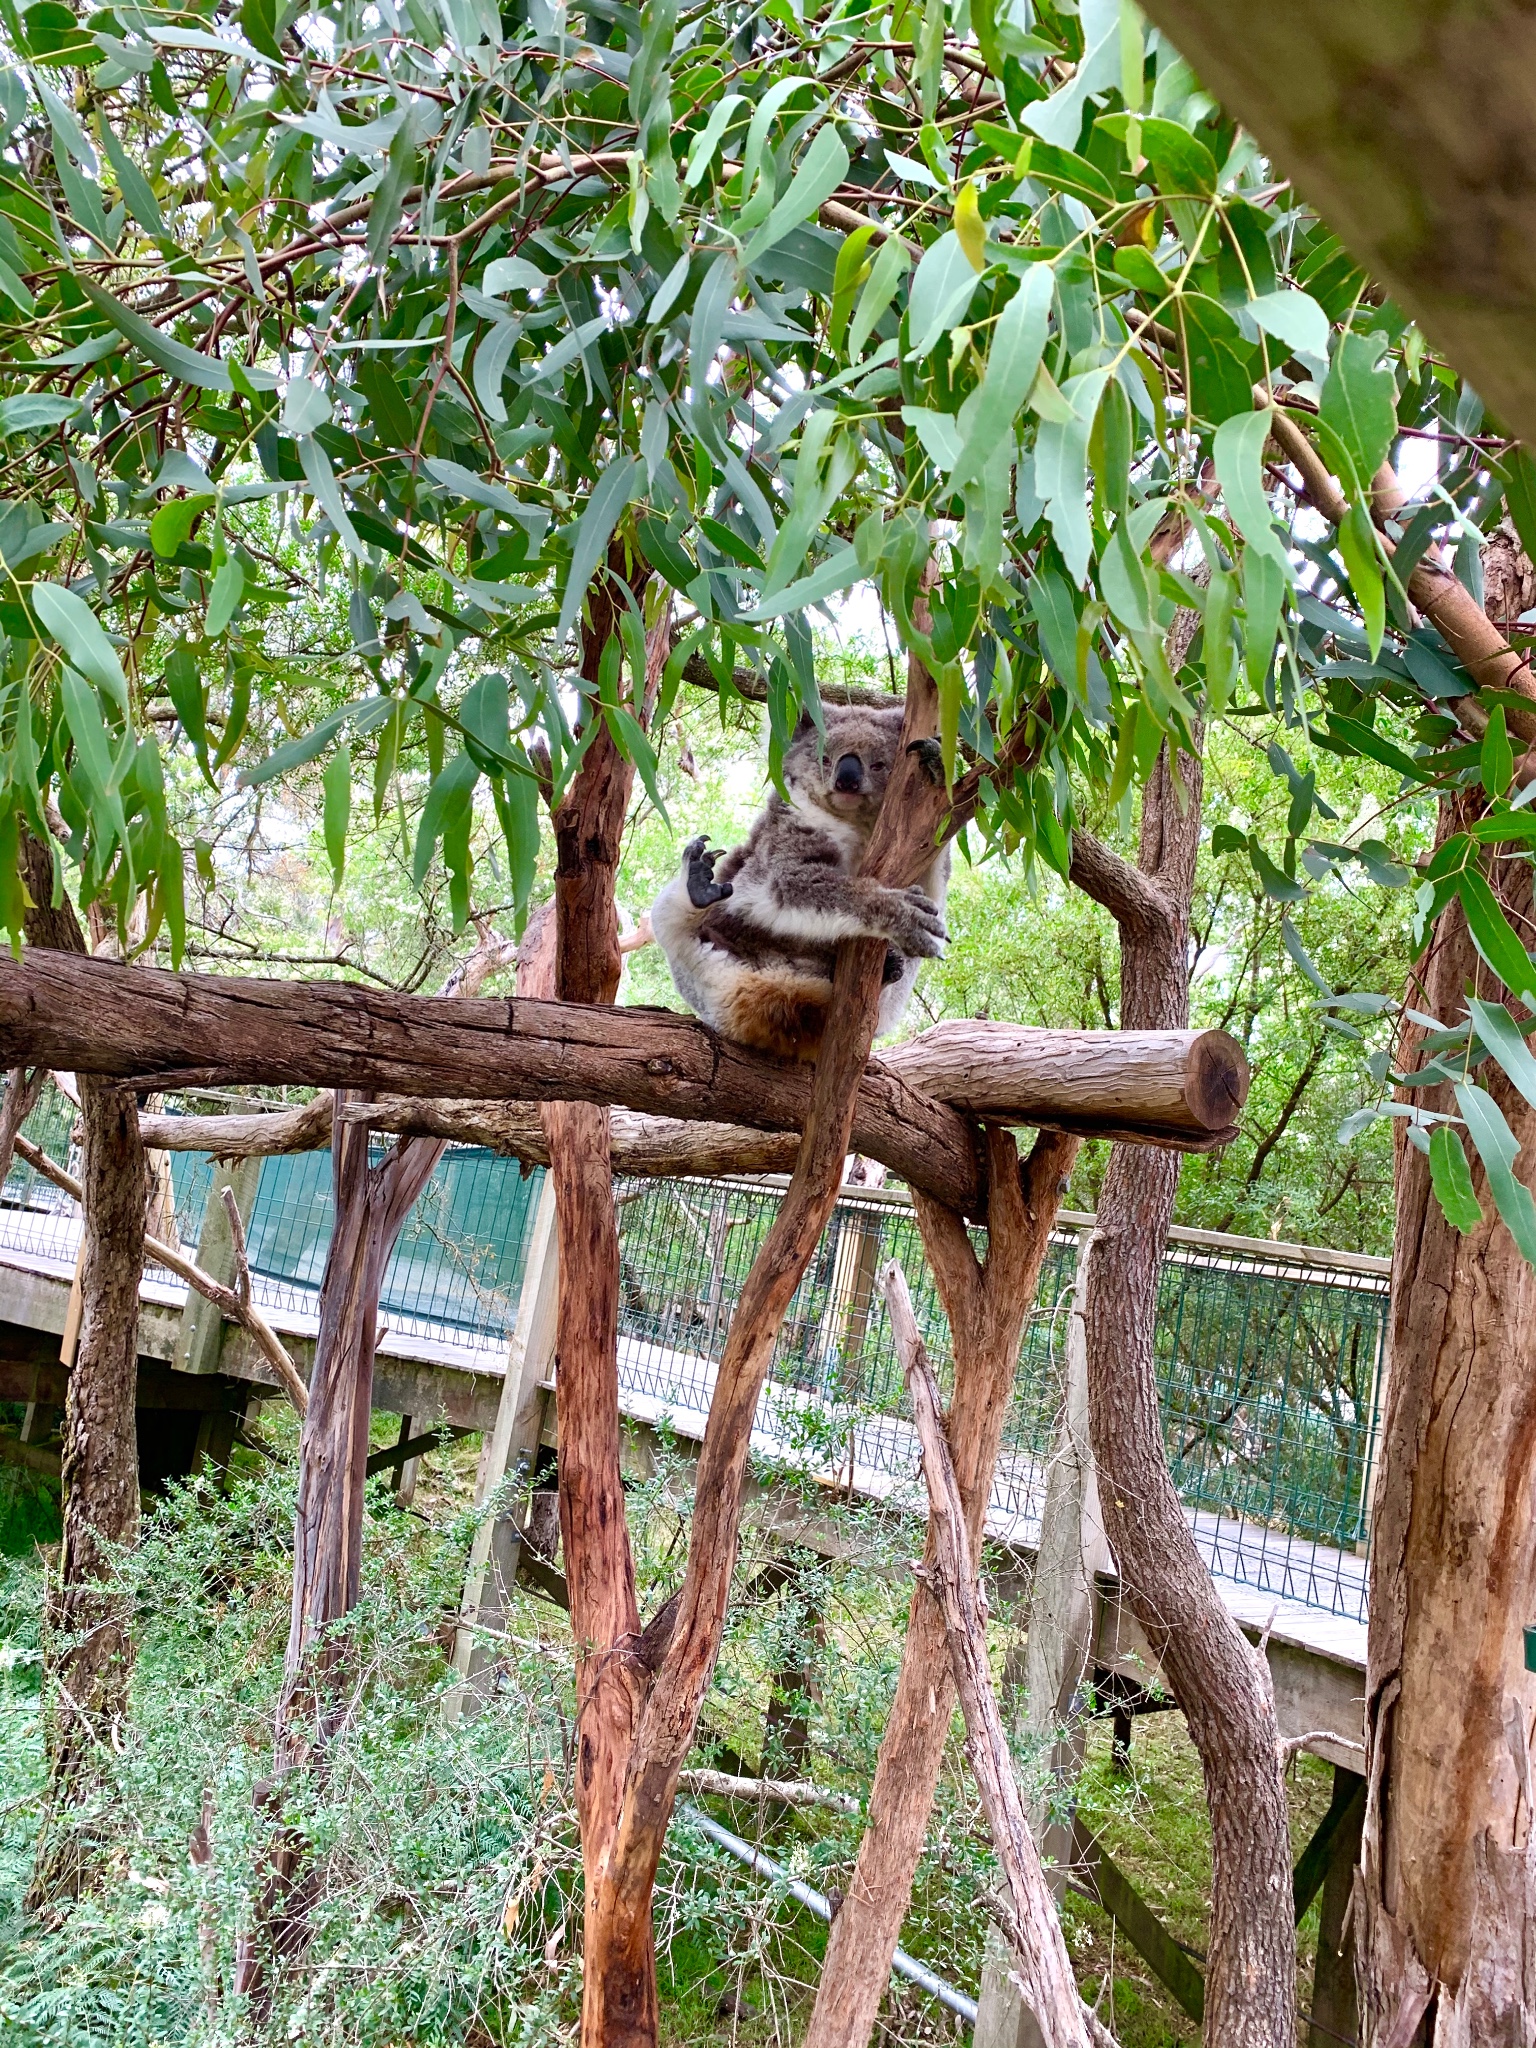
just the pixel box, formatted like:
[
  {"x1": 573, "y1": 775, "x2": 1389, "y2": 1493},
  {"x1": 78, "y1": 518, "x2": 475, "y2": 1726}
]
[{"x1": 20, "y1": 836, "x2": 150, "y2": 1911}]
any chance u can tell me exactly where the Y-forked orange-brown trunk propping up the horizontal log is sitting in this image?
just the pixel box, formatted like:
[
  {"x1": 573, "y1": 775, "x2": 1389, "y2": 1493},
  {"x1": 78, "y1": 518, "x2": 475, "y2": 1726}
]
[{"x1": 805, "y1": 1124, "x2": 1077, "y2": 2048}]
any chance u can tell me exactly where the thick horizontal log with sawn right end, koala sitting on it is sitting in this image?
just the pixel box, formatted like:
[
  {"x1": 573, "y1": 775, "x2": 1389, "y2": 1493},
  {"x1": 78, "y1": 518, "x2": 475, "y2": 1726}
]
[{"x1": 0, "y1": 948, "x2": 1247, "y2": 1217}]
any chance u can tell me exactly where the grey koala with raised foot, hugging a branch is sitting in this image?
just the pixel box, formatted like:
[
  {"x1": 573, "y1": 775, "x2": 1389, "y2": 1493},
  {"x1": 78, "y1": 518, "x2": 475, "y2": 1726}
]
[{"x1": 651, "y1": 707, "x2": 950, "y2": 1059}]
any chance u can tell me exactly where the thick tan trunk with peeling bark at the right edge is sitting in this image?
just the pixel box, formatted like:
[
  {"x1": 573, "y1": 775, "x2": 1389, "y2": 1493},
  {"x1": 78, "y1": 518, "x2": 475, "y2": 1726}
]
[{"x1": 1354, "y1": 799, "x2": 1536, "y2": 2048}]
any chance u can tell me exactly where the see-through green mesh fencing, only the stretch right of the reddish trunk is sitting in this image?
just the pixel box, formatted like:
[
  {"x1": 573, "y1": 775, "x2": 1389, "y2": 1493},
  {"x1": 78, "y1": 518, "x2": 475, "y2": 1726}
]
[{"x1": 618, "y1": 1182, "x2": 1386, "y2": 1620}]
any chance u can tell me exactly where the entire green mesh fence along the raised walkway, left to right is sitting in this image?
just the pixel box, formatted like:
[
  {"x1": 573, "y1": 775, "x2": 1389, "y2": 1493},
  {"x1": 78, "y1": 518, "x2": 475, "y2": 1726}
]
[{"x1": 0, "y1": 1090, "x2": 1389, "y2": 1620}]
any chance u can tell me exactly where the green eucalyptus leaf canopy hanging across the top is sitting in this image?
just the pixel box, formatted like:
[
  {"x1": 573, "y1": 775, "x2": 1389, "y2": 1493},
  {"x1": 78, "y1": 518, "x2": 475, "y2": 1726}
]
[{"x1": 0, "y1": 0, "x2": 1536, "y2": 1243}]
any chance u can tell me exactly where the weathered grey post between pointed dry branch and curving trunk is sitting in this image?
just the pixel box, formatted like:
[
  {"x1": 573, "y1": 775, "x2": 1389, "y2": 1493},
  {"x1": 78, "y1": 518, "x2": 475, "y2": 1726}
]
[{"x1": 977, "y1": 1231, "x2": 1112, "y2": 2048}]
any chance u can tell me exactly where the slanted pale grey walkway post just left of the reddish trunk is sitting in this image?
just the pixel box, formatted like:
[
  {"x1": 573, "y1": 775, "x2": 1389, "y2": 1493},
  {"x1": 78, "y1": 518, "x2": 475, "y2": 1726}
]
[{"x1": 442, "y1": 1180, "x2": 559, "y2": 1720}]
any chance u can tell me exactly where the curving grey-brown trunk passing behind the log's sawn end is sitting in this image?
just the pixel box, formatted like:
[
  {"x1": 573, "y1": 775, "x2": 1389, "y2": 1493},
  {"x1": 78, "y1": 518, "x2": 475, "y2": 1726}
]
[{"x1": 1071, "y1": 750, "x2": 1296, "y2": 2048}]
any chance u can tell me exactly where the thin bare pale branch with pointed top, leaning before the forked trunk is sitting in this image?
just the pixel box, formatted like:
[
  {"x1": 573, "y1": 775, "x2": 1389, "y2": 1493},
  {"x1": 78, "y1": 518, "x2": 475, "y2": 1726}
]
[{"x1": 883, "y1": 1260, "x2": 1090, "y2": 2048}]
